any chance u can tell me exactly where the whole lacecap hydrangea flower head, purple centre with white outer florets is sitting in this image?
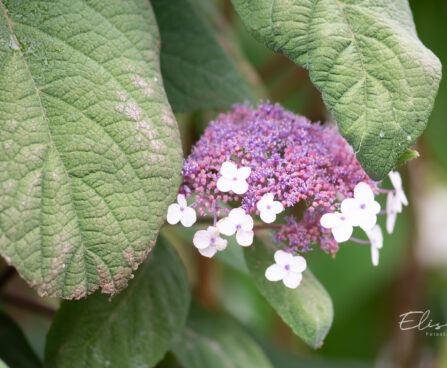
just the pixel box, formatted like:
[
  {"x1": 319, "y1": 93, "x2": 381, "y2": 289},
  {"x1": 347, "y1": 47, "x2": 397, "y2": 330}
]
[{"x1": 167, "y1": 104, "x2": 408, "y2": 288}]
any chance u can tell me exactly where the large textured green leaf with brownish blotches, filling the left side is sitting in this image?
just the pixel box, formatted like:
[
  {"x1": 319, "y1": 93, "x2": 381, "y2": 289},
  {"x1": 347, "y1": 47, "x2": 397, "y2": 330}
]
[{"x1": 0, "y1": 0, "x2": 181, "y2": 299}]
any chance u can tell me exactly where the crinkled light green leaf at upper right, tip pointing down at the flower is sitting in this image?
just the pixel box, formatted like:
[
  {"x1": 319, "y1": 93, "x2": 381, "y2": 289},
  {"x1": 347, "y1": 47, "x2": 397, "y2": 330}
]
[{"x1": 232, "y1": 0, "x2": 441, "y2": 180}]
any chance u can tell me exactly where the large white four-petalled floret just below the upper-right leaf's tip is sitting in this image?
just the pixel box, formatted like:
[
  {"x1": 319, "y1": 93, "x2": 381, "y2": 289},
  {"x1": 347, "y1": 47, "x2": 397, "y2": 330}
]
[{"x1": 341, "y1": 182, "x2": 380, "y2": 231}]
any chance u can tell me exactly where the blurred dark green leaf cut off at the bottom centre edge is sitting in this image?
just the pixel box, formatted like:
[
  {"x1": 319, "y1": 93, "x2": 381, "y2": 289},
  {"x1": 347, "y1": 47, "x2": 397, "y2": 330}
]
[{"x1": 171, "y1": 305, "x2": 272, "y2": 368}]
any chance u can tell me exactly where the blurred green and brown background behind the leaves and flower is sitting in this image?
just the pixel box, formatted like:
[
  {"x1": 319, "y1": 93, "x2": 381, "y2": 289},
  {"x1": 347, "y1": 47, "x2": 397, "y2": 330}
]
[{"x1": 0, "y1": 0, "x2": 447, "y2": 368}]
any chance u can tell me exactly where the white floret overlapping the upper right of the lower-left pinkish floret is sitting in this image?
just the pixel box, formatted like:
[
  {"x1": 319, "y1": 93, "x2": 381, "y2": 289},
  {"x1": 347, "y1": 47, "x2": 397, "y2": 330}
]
[{"x1": 216, "y1": 208, "x2": 254, "y2": 247}]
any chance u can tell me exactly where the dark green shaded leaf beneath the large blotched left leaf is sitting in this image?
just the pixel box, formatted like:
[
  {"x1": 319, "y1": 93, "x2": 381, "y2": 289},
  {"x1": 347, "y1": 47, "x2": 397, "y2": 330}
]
[{"x1": 45, "y1": 238, "x2": 190, "y2": 368}]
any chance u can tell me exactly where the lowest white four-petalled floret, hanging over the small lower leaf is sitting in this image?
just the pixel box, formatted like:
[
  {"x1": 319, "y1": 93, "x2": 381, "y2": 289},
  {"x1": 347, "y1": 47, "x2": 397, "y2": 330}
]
[{"x1": 265, "y1": 250, "x2": 307, "y2": 289}]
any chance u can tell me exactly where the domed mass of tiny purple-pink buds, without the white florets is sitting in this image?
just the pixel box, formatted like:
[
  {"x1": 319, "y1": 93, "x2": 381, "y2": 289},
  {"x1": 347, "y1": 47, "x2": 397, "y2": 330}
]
[{"x1": 180, "y1": 104, "x2": 376, "y2": 253}]
